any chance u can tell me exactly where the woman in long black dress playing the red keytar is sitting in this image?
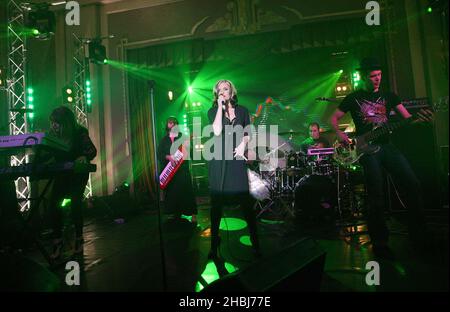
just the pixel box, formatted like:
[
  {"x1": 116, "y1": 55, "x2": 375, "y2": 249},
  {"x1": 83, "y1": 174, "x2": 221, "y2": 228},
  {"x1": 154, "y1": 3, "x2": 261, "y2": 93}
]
[{"x1": 158, "y1": 117, "x2": 197, "y2": 225}]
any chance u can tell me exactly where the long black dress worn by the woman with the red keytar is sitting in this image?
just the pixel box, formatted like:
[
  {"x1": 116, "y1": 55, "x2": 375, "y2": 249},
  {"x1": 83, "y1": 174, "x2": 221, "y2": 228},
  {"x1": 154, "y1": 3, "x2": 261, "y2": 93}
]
[{"x1": 158, "y1": 133, "x2": 197, "y2": 216}]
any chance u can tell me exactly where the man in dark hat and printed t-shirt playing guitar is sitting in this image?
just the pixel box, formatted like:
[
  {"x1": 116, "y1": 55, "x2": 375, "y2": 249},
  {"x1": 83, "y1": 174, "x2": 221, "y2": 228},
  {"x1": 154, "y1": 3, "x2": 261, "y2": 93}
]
[{"x1": 331, "y1": 58, "x2": 425, "y2": 258}]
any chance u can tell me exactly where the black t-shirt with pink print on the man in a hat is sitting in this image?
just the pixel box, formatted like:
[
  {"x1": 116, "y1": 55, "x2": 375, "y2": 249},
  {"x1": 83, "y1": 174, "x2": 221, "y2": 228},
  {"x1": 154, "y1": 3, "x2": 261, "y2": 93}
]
[{"x1": 339, "y1": 90, "x2": 401, "y2": 135}]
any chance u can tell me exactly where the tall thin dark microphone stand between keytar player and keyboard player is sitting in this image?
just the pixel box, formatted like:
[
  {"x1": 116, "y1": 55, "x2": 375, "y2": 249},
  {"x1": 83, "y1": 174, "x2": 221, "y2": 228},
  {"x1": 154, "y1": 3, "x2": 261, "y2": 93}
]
[{"x1": 148, "y1": 80, "x2": 167, "y2": 291}]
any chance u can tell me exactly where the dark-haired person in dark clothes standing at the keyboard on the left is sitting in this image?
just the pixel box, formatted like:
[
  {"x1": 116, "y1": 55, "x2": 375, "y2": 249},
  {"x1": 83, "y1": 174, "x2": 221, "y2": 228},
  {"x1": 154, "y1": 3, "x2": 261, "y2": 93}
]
[{"x1": 49, "y1": 106, "x2": 97, "y2": 260}]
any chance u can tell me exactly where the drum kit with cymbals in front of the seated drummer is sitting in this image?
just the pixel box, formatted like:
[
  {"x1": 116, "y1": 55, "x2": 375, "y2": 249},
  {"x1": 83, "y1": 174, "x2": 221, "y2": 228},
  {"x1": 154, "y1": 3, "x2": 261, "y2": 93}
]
[{"x1": 248, "y1": 132, "x2": 368, "y2": 225}]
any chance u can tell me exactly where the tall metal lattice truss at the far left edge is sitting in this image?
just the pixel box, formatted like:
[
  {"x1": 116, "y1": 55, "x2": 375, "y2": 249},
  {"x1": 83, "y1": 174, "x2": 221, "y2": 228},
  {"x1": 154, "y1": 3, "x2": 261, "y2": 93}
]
[{"x1": 6, "y1": 0, "x2": 30, "y2": 211}]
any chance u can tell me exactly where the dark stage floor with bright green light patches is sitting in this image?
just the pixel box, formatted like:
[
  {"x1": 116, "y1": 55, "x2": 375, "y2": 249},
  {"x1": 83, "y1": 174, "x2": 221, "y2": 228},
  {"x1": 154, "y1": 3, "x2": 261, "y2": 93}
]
[{"x1": 2, "y1": 200, "x2": 448, "y2": 292}]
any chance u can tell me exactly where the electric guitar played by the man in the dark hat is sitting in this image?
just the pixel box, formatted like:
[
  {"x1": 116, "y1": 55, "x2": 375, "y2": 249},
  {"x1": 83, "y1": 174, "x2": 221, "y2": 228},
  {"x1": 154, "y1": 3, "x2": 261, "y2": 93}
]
[{"x1": 335, "y1": 109, "x2": 433, "y2": 166}]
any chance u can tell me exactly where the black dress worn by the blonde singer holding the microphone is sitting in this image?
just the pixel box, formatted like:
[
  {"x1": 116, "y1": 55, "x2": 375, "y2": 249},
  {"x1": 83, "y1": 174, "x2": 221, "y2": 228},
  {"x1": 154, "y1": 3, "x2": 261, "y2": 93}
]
[{"x1": 208, "y1": 105, "x2": 250, "y2": 195}]
